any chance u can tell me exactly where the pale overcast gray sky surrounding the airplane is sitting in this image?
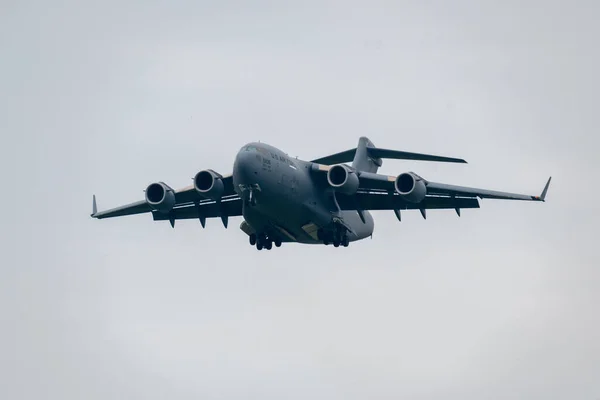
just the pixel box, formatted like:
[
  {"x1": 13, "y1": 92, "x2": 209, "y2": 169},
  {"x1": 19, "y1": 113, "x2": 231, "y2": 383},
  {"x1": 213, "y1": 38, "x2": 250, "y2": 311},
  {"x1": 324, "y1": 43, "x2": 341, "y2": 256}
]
[{"x1": 0, "y1": 0, "x2": 600, "y2": 400}]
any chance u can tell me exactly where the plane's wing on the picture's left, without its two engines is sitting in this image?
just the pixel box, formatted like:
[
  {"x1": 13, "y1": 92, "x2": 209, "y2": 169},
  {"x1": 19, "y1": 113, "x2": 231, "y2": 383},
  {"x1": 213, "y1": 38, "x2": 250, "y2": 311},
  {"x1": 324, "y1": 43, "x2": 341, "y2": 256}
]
[{"x1": 91, "y1": 176, "x2": 239, "y2": 225}]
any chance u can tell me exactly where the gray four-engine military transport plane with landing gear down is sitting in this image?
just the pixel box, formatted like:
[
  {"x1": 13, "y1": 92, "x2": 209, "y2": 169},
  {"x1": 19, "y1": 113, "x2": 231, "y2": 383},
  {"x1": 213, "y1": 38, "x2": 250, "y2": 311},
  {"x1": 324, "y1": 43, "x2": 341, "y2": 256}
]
[{"x1": 91, "y1": 137, "x2": 551, "y2": 250}]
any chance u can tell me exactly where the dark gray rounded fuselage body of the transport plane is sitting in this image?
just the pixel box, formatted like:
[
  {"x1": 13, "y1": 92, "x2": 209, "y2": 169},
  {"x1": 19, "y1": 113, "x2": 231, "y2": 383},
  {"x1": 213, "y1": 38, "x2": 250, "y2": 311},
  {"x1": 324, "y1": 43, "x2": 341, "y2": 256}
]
[{"x1": 232, "y1": 142, "x2": 374, "y2": 244}]
